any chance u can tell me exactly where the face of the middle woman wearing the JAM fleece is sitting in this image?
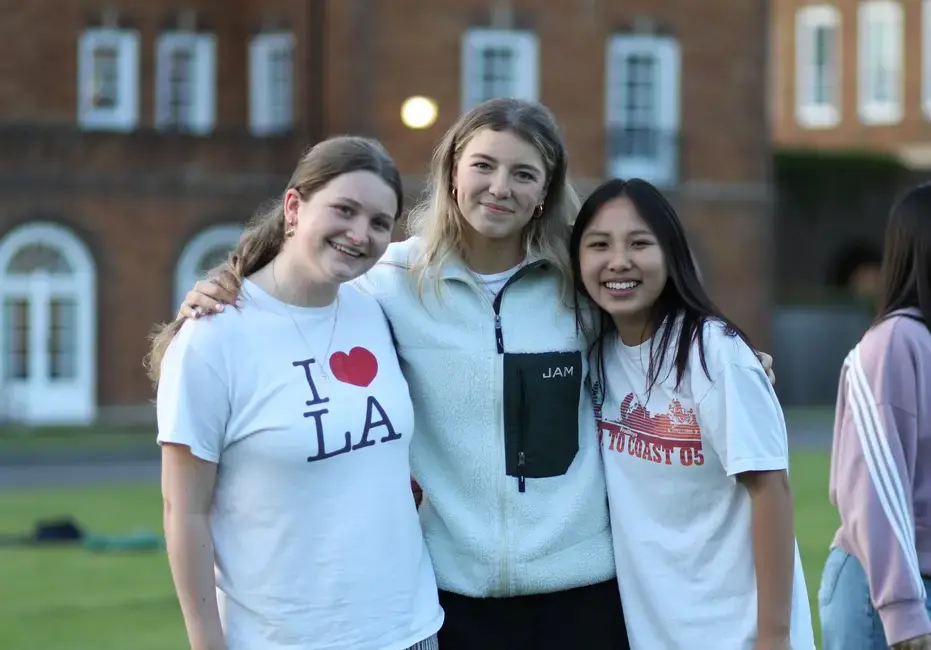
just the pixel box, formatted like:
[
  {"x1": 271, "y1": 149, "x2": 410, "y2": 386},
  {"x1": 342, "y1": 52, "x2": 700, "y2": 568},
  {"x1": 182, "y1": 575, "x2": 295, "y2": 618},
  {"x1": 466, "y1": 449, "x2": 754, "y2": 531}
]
[{"x1": 454, "y1": 128, "x2": 546, "y2": 240}]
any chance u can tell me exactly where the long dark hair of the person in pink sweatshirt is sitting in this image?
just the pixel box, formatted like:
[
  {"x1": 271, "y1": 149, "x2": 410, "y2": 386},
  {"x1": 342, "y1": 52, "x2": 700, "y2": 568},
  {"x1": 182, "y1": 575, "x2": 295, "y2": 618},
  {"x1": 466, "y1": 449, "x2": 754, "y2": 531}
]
[{"x1": 877, "y1": 182, "x2": 931, "y2": 328}]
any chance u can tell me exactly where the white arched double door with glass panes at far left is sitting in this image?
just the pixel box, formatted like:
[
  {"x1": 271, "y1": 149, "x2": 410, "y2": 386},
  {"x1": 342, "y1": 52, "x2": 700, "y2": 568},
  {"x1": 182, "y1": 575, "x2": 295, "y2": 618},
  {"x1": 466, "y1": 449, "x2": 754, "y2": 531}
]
[{"x1": 0, "y1": 225, "x2": 96, "y2": 424}]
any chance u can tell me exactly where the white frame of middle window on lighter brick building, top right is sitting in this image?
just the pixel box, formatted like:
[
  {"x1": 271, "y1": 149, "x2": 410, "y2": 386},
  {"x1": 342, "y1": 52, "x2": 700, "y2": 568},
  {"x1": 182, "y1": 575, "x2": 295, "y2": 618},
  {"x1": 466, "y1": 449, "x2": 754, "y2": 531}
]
[{"x1": 857, "y1": 0, "x2": 905, "y2": 125}]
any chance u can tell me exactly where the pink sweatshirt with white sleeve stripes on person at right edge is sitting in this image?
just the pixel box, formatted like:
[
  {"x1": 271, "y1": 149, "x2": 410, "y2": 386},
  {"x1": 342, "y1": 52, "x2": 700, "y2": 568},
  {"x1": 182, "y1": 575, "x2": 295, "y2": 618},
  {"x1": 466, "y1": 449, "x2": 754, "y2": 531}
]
[{"x1": 830, "y1": 310, "x2": 931, "y2": 645}]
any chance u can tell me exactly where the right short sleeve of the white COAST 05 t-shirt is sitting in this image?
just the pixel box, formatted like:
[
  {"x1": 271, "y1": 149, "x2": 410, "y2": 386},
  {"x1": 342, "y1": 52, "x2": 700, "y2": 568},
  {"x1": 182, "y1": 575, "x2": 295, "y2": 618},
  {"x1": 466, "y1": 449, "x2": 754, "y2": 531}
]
[{"x1": 696, "y1": 362, "x2": 789, "y2": 476}]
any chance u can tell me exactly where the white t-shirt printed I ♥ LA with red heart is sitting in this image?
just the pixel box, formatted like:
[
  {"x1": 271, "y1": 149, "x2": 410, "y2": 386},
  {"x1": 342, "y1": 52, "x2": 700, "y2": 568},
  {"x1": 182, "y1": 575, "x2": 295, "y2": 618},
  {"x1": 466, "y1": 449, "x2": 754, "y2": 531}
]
[{"x1": 158, "y1": 281, "x2": 443, "y2": 650}]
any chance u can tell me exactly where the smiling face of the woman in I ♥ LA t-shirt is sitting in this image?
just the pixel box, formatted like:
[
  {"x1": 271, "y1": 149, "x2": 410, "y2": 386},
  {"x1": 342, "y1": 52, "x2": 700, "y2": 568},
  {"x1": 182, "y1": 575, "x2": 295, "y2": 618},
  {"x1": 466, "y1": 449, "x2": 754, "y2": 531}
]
[{"x1": 283, "y1": 171, "x2": 398, "y2": 284}]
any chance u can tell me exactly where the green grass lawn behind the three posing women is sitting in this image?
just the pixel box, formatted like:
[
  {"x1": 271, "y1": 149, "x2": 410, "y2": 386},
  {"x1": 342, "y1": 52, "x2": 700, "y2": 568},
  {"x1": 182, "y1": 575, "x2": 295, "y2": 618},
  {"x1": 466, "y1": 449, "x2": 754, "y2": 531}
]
[{"x1": 0, "y1": 452, "x2": 837, "y2": 650}]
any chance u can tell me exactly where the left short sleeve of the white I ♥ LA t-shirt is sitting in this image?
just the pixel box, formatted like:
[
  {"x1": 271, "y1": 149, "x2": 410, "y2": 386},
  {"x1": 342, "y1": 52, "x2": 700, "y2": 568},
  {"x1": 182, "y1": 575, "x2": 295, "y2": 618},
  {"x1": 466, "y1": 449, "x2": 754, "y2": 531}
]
[{"x1": 156, "y1": 323, "x2": 230, "y2": 463}]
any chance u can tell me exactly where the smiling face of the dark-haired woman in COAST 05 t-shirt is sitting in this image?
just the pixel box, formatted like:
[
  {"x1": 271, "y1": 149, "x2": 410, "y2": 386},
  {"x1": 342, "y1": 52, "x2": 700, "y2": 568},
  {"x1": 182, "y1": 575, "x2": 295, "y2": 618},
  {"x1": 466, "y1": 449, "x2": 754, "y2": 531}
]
[{"x1": 579, "y1": 197, "x2": 668, "y2": 345}]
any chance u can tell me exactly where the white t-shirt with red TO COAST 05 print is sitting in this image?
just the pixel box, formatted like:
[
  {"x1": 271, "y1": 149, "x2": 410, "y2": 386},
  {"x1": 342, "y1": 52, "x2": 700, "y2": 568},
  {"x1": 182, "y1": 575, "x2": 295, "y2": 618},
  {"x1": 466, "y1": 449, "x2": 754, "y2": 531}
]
[{"x1": 596, "y1": 323, "x2": 815, "y2": 650}]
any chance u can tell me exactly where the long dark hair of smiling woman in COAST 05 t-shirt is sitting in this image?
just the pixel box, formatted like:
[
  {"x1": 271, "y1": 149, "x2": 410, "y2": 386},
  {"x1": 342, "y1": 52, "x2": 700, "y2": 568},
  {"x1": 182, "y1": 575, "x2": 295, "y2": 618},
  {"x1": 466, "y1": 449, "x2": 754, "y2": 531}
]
[{"x1": 569, "y1": 178, "x2": 752, "y2": 398}]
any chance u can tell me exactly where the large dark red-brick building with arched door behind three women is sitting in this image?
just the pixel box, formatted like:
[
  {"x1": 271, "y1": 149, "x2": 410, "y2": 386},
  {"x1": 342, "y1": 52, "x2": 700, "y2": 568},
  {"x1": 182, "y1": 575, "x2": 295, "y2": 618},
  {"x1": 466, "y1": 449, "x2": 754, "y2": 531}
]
[{"x1": 0, "y1": 0, "x2": 772, "y2": 422}]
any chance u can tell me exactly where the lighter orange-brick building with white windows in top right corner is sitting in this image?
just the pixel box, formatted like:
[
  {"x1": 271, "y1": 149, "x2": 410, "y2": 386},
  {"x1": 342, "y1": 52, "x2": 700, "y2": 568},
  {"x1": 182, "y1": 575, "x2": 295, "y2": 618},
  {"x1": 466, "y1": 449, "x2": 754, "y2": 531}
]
[{"x1": 772, "y1": 0, "x2": 931, "y2": 159}]
